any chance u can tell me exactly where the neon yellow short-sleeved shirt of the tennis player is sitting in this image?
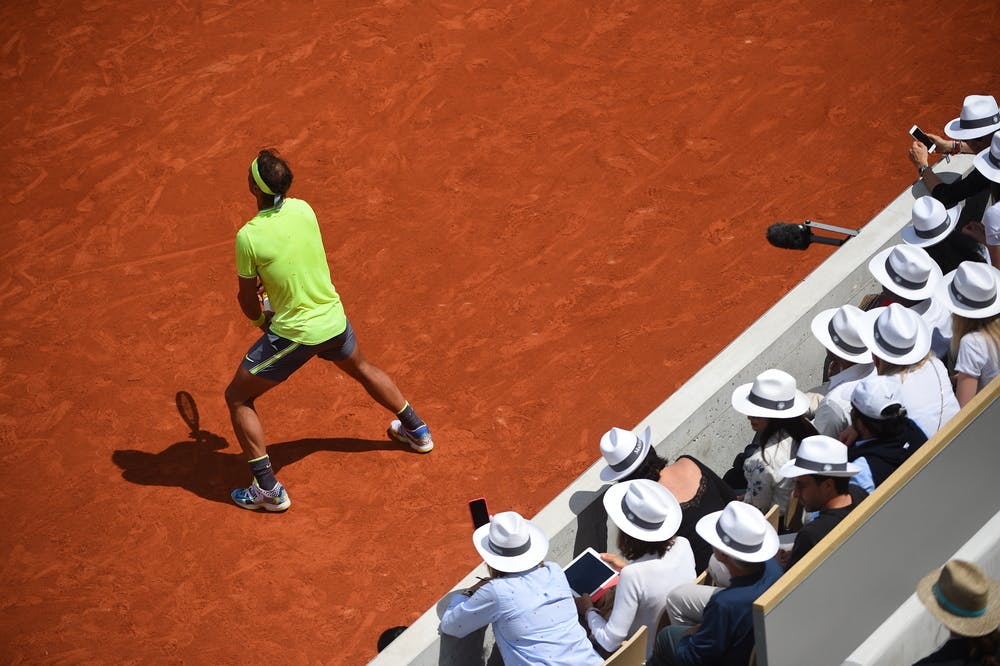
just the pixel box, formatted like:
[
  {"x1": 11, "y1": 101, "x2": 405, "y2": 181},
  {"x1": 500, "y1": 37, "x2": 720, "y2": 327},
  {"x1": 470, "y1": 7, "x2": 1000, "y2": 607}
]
[{"x1": 236, "y1": 199, "x2": 347, "y2": 345}]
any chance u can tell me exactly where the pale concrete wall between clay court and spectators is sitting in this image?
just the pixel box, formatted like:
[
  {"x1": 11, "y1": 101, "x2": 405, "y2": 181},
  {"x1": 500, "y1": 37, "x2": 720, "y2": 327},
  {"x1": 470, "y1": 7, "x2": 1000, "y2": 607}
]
[{"x1": 370, "y1": 156, "x2": 971, "y2": 666}]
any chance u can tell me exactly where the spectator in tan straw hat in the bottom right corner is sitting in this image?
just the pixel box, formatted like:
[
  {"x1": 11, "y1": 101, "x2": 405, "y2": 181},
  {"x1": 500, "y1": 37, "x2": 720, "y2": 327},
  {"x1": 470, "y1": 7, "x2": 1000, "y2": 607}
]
[{"x1": 916, "y1": 560, "x2": 1000, "y2": 666}]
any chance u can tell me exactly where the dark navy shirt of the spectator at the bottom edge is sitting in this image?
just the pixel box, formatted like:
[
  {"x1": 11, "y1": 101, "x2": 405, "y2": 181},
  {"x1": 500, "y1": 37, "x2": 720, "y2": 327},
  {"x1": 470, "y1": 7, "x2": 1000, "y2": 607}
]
[{"x1": 674, "y1": 558, "x2": 783, "y2": 666}]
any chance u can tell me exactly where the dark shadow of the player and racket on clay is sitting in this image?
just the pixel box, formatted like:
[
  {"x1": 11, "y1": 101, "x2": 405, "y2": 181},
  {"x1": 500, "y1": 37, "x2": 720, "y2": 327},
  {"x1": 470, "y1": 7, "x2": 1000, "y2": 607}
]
[{"x1": 111, "y1": 391, "x2": 410, "y2": 504}]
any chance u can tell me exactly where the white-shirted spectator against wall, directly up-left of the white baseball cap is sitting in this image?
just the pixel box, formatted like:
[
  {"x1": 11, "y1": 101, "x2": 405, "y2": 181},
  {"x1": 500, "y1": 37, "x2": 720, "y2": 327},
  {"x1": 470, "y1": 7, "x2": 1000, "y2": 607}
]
[{"x1": 811, "y1": 305, "x2": 875, "y2": 437}]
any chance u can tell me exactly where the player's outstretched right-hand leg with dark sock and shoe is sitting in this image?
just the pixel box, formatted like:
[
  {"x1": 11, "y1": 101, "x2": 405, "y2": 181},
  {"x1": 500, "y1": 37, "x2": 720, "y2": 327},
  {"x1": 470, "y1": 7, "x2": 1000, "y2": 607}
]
[{"x1": 319, "y1": 322, "x2": 434, "y2": 453}]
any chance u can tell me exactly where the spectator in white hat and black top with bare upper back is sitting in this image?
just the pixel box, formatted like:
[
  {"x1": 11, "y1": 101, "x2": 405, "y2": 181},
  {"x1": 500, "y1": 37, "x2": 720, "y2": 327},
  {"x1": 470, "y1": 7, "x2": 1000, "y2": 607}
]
[{"x1": 600, "y1": 428, "x2": 745, "y2": 571}]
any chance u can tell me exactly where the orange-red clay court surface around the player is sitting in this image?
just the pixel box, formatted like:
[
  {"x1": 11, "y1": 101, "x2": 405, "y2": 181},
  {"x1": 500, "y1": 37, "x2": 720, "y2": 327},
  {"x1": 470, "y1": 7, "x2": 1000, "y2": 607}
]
[{"x1": 0, "y1": 0, "x2": 1000, "y2": 664}]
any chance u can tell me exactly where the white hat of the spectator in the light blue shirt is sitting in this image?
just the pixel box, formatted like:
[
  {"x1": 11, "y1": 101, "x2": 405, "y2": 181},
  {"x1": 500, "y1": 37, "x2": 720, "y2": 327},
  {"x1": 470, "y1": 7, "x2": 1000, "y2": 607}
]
[{"x1": 472, "y1": 511, "x2": 549, "y2": 573}]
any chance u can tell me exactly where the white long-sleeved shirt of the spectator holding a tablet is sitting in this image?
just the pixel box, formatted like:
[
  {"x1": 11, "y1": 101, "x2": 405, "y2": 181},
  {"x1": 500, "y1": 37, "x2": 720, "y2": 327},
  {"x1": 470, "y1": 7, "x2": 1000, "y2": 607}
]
[{"x1": 587, "y1": 537, "x2": 696, "y2": 659}]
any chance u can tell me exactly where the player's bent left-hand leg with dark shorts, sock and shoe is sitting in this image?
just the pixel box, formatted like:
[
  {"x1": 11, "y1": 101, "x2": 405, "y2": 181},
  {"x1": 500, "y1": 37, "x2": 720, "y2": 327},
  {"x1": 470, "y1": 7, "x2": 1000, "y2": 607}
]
[{"x1": 226, "y1": 332, "x2": 316, "y2": 511}]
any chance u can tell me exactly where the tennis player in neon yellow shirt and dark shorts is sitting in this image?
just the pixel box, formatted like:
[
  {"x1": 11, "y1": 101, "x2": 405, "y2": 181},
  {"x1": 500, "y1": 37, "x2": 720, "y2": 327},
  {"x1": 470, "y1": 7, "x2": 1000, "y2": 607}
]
[{"x1": 226, "y1": 150, "x2": 434, "y2": 511}]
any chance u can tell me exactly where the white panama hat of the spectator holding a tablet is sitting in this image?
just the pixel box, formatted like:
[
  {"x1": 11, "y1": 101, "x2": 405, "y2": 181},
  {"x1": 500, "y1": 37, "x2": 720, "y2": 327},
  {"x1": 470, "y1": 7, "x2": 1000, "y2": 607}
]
[{"x1": 604, "y1": 479, "x2": 682, "y2": 543}]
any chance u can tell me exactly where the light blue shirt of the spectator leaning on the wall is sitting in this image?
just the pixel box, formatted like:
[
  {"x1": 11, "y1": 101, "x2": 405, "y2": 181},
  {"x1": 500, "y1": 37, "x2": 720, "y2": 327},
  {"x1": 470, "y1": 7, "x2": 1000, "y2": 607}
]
[{"x1": 441, "y1": 562, "x2": 604, "y2": 666}]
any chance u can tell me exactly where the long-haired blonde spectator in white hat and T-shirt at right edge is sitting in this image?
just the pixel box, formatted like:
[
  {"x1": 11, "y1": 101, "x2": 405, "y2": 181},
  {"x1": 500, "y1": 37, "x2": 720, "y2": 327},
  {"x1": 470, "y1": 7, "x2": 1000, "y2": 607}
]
[{"x1": 939, "y1": 261, "x2": 1000, "y2": 406}]
